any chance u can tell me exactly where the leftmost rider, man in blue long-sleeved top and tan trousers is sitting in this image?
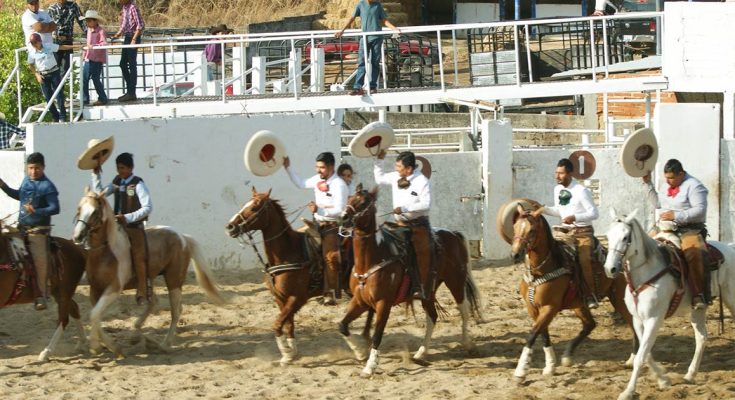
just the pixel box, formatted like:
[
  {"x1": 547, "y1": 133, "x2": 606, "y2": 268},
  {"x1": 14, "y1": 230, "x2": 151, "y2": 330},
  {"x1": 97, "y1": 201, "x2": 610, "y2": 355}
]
[{"x1": 0, "y1": 153, "x2": 60, "y2": 310}]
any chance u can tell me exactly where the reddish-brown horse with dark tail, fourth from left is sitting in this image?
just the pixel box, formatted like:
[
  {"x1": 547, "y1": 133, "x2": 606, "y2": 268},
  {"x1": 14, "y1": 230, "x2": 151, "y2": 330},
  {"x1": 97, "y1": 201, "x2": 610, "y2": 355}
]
[{"x1": 339, "y1": 185, "x2": 480, "y2": 376}]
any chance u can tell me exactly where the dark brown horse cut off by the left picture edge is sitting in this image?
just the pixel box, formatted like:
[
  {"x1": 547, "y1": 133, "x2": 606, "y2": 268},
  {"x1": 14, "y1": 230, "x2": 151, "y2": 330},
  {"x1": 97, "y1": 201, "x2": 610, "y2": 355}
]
[{"x1": 0, "y1": 225, "x2": 86, "y2": 361}]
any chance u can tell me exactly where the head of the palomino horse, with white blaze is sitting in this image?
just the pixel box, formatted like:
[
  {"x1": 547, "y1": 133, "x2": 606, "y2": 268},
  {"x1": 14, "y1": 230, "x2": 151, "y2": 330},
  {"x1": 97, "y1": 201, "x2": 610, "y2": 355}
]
[{"x1": 73, "y1": 186, "x2": 114, "y2": 248}]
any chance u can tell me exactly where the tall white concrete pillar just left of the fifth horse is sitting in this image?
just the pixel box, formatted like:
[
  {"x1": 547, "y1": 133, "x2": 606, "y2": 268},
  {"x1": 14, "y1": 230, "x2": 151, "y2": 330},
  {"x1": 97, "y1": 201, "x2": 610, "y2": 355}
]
[{"x1": 481, "y1": 119, "x2": 513, "y2": 260}]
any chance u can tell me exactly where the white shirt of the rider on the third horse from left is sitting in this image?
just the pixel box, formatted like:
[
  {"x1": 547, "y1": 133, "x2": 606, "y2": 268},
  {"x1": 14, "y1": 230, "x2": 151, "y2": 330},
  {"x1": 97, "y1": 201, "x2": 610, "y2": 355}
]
[{"x1": 286, "y1": 168, "x2": 349, "y2": 222}]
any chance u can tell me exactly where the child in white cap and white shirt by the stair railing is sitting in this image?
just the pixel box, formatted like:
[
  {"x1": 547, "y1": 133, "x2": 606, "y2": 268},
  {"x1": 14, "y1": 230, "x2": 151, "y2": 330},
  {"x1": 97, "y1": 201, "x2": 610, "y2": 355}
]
[{"x1": 28, "y1": 32, "x2": 73, "y2": 122}]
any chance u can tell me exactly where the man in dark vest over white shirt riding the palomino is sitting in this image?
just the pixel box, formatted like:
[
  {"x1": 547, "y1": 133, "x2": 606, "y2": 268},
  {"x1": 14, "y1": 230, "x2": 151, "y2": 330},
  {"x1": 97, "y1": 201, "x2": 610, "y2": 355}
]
[{"x1": 92, "y1": 153, "x2": 153, "y2": 305}]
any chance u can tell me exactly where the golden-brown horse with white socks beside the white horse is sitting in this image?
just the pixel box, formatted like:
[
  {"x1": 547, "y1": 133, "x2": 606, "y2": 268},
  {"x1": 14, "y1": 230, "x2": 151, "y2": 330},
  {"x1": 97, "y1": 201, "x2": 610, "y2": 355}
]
[{"x1": 511, "y1": 205, "x2": 638, "y2": 381}]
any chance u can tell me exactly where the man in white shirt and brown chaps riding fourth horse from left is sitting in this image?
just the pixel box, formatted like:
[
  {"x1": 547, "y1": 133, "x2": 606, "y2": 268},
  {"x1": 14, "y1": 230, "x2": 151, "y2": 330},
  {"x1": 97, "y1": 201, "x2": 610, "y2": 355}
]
[{"x1": 374, "y1": 150, "x2": 433, "y2": 300}]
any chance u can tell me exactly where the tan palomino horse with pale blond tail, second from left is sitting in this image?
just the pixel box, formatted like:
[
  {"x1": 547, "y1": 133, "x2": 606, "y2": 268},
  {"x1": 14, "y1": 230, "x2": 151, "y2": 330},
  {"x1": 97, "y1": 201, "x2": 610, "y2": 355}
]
[{"x1": 74, "y1": 188, "x2": 224, "y2": 356}]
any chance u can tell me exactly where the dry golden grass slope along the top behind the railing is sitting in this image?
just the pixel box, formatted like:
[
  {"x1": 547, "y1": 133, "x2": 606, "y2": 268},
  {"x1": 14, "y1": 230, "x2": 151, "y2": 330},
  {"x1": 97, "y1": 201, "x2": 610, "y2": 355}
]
[{"x1": 36, "y1": 0, "x2": 329, "y2": 32}]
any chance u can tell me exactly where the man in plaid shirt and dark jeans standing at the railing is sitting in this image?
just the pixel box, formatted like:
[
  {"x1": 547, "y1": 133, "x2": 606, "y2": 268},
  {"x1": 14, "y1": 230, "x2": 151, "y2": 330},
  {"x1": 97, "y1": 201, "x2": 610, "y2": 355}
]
[{"x1": 112, "y1": 0, "x2": 145, "y2": 101}]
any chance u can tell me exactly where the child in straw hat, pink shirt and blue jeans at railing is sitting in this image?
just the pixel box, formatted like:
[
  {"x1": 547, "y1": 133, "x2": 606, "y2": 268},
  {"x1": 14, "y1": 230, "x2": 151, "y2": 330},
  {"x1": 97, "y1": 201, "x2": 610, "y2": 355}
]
[{"x1": 82, "y1": 10, "x2": 108, "y2": 106}]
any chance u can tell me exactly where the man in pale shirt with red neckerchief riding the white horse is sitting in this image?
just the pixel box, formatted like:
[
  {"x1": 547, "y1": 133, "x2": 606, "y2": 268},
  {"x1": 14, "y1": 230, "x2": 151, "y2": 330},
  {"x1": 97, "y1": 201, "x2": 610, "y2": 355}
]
[{"x1": 642, "y1": 158, "x2": 710, "y2": 309}]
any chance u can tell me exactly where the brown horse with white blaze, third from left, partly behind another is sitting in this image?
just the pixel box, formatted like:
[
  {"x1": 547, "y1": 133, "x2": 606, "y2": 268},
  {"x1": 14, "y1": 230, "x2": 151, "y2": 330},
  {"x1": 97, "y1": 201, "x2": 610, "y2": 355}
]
[{"x1": 225, "y1": 187, "x2": 352, "y2": 365}]
